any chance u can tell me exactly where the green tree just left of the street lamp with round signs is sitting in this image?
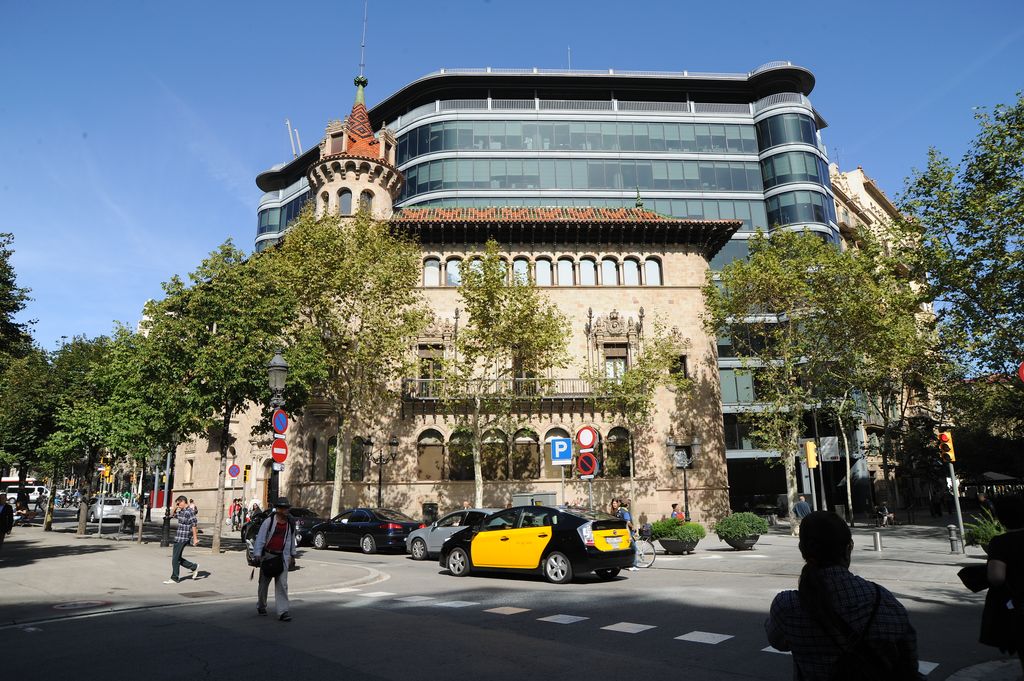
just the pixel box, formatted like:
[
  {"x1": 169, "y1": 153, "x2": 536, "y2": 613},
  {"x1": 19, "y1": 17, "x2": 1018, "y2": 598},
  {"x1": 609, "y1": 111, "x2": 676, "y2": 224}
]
[{"x1": 141, "y1": 241, "x2": 295, "y2": 553}]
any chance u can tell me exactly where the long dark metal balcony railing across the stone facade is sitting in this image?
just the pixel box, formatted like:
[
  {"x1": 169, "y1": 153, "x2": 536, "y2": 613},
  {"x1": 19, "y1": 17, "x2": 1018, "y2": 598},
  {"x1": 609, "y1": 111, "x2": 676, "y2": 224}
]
[{"x1": 401, "y1": 378, "x2": 601, "y2": 399}]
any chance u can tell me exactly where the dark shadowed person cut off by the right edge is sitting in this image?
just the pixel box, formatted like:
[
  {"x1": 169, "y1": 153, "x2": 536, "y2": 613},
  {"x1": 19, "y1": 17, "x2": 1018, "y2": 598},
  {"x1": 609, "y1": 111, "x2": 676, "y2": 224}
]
[{"x1": 979, "y1": 495, "x2": 1024, "y2": 670}]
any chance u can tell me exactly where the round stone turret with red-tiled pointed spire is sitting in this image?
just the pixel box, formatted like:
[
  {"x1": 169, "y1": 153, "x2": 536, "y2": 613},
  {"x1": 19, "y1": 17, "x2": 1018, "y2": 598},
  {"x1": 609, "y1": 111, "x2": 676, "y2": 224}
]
[{"x1": 306, "y1": 74, "x2": 404, "y2": 220}]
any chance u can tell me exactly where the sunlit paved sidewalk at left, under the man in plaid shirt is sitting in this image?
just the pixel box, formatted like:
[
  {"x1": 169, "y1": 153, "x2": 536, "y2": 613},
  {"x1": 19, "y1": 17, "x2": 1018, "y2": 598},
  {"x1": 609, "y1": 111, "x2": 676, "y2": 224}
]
[{"x1": 0, "y1": 523, "x2": 382, "y2": 628}]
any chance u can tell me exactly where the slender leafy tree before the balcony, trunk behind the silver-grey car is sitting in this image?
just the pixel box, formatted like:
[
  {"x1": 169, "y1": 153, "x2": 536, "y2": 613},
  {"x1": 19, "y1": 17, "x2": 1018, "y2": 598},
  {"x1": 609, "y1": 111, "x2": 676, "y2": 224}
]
[{"x1": 440, "y1": 240, "x2": 568, "y2": 507}]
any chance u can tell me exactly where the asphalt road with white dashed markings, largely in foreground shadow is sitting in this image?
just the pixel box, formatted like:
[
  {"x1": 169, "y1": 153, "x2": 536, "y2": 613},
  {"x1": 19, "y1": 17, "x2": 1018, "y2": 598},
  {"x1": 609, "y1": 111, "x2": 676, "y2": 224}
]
[{"x1": 0, "y1": 512, "x2": 998, "y2": 681}]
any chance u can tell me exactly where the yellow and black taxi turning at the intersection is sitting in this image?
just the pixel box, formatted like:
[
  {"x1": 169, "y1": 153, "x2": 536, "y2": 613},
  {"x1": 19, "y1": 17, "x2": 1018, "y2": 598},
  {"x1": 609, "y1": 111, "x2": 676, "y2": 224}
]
[{"x1": 440, "y1": 506, "x2": 633, "y2": 584}]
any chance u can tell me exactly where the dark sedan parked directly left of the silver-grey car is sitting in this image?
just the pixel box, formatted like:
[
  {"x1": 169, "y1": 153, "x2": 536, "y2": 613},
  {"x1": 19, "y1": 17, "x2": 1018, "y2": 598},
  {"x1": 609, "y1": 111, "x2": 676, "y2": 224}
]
[{"x1": 312, "y1": 508, "x2": 425, "y2": 553}]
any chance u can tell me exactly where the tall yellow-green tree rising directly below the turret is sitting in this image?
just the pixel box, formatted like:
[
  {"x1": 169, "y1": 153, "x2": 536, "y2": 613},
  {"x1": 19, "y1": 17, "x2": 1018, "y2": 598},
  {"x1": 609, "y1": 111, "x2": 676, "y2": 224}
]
[{"x1": 272, "y1": 209, "x2": 427, "y2": 515}]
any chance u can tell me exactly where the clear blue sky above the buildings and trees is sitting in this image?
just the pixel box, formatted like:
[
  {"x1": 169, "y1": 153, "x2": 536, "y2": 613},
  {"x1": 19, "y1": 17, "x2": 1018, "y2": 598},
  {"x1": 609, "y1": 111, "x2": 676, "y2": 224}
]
[{"x1": 0, "y1": 0, "x2": 1024, "y2": 349}]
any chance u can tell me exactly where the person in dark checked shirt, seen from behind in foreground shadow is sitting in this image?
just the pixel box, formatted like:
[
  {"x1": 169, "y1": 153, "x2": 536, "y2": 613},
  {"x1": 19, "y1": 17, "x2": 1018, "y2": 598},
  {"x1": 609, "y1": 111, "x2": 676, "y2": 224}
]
[{"x1": 765, "y1": 511, "x2": 923, "y2": 681}]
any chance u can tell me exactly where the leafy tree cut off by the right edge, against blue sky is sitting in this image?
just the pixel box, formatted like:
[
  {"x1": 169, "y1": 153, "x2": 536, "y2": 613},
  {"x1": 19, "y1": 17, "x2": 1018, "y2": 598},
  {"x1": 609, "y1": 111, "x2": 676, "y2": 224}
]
[{"x1": 901, "y1": 93, "x2": 1024, "y2": 438}]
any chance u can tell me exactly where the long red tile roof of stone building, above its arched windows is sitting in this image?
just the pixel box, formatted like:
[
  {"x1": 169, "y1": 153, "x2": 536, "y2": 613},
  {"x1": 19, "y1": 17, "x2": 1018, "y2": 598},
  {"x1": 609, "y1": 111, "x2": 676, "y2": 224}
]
[{"x1": 392, "y1": 206, "x2": 733, "y2": 225}]
